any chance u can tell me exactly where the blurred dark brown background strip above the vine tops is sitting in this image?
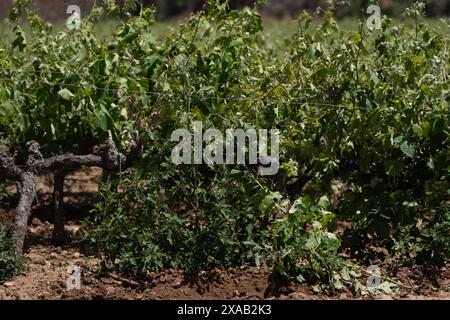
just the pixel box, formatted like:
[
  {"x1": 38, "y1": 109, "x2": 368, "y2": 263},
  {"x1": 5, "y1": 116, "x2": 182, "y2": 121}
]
[{"x1": 0, "y1": 0, "x2": 450, "y2": 22}]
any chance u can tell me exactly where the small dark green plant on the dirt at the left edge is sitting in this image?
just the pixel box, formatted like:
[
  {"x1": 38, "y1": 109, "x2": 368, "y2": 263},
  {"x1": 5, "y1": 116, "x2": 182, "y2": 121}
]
[{"x1": 0, "y1": 225, "x2": 24, "y2": 283}]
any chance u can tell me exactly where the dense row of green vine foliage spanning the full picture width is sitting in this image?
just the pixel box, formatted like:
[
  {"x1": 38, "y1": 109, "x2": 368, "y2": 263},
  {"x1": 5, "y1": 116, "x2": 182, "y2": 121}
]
[{"x1": 0, "y1": 1, "x2": 450, "y2": 288}]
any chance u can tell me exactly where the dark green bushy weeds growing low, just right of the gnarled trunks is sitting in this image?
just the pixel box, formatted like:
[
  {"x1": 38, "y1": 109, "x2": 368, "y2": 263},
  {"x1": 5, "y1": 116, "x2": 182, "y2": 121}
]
[{"x1": 87, "y1": 165, "x2": 270, "y2": 272}]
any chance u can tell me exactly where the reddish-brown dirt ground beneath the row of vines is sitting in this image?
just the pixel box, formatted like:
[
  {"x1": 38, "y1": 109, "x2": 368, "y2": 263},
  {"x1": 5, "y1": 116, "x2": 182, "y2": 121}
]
[{"x1": 0, "y1": 171, "x2": 450, "y2": 300}]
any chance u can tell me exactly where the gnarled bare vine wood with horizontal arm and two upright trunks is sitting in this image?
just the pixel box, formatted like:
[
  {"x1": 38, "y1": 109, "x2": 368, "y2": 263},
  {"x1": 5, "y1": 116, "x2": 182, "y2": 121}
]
[{"x1": 0, "y1": 133, "x2": 141, "y2": 257}]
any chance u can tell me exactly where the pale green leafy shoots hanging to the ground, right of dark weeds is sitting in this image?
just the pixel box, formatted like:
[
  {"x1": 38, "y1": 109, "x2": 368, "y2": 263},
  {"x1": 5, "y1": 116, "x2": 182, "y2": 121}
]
[{"x1": 273, "y1": 196, "x2": 343, "y2": 284}]
